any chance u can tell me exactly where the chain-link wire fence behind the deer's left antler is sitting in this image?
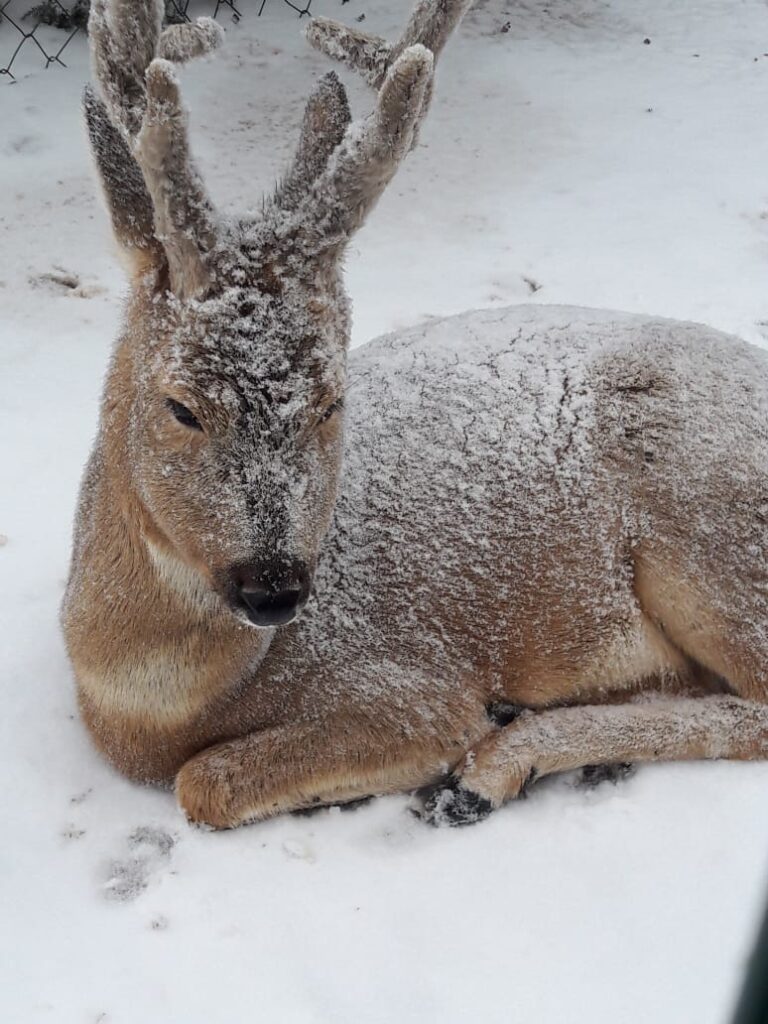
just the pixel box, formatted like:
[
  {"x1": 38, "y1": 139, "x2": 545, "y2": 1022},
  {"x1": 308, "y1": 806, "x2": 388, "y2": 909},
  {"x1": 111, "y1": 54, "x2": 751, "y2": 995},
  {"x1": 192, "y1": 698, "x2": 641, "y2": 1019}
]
[{"x1": 0, "y1": 0, "x2": 312, "y2": 81}]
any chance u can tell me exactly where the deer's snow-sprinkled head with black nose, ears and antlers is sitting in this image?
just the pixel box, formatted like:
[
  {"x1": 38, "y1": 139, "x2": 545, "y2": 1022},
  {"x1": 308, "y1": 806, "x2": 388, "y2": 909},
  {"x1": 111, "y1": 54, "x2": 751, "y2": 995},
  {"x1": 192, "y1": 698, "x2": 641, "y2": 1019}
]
[{"x1": 85, "y1": 0, "x2": 466, "y2": 626}]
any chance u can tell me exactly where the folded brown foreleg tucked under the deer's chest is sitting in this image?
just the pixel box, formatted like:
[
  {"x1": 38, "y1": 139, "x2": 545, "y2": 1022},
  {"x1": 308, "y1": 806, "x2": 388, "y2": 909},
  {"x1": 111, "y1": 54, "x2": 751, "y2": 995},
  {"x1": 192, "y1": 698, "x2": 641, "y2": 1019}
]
[{"x1": 176, "y1": 708, "x2": 490, "y2": 828}]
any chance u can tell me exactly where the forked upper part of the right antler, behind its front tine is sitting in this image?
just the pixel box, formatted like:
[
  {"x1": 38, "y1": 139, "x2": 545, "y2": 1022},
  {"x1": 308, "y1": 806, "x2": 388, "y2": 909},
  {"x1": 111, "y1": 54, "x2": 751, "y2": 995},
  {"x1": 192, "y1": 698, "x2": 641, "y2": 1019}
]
[{"x1": 306, "y1": 0, "x2": 474, "y2": 89}]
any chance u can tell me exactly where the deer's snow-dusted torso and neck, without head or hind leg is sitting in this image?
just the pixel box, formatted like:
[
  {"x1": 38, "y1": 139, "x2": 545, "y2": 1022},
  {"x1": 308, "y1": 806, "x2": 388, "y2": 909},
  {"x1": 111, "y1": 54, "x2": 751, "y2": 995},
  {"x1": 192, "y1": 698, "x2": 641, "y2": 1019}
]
[{"x1": 69, "y1": 307, "x2": 768, "y2": 824}]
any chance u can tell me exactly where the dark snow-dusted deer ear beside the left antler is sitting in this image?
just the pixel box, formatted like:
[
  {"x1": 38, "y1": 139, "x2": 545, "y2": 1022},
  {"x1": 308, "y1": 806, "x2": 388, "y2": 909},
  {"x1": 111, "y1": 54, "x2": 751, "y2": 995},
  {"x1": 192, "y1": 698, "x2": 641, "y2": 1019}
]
[{"x1": 83, "y1": 86, "x2": 165, "y2": 273}]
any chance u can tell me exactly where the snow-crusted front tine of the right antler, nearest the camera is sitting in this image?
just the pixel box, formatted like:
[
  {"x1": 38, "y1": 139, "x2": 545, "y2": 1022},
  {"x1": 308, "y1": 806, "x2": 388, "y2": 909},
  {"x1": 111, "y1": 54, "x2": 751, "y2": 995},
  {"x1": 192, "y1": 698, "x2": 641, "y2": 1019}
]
[{"x1": 297, "y1": 46, "x2": 434, "y2": 250}]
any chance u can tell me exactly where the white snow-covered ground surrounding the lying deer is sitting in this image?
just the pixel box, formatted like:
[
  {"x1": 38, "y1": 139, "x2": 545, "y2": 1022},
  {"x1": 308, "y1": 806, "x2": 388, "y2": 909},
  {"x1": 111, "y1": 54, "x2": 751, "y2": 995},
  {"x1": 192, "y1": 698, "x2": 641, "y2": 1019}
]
[{"x1": 0, "y1": 0, "x2": 768, "y2": 1024}]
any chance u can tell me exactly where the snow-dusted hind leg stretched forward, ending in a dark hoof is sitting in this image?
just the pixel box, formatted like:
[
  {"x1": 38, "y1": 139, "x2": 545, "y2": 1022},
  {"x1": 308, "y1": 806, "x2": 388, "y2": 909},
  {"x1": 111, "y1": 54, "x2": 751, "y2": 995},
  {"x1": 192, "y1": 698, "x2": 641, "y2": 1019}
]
[{"x1": 424, "y1": 696, "x2": 768, "y2": 825}]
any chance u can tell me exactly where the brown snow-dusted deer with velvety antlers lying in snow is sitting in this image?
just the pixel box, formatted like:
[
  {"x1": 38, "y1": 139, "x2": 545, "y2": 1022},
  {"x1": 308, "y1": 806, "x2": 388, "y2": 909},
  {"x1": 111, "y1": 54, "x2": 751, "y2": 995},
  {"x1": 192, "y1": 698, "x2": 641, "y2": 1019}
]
[{"x1": 63, "y1": 0, "x2": 768, "y2": 826}]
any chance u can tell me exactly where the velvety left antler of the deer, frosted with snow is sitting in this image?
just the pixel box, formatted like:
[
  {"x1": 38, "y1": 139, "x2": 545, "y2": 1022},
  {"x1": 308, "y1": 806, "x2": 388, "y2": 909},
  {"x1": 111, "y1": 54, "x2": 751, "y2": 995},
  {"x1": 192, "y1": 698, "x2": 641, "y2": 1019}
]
[{"x1": 88, "y1": 0, "x2": 223, "y2": 299}]
